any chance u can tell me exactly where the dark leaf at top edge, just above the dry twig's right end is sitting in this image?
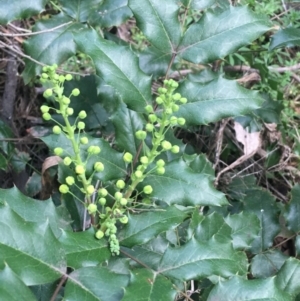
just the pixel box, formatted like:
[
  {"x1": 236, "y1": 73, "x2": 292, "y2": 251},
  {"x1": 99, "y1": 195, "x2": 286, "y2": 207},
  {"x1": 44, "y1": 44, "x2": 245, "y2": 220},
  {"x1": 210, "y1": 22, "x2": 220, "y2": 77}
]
[{"x1": 60, "y1": 0, "x2": 102, "y2": 22}]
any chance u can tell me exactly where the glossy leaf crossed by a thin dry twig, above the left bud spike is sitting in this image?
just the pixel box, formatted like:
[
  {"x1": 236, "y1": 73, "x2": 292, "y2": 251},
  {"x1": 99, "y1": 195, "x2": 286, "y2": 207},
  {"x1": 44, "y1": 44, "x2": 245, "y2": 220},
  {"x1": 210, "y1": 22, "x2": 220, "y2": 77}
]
[{"x1": 22, "y1": 14, "x2": 84, "y2": 84}]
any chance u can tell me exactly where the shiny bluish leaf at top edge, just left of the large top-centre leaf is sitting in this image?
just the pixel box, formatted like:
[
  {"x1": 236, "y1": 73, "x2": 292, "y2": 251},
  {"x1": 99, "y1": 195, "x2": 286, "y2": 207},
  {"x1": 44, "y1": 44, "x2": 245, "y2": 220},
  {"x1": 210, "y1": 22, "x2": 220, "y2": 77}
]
[{"x1": 89, "y1": 0, "x2": 132, "y2": 27}]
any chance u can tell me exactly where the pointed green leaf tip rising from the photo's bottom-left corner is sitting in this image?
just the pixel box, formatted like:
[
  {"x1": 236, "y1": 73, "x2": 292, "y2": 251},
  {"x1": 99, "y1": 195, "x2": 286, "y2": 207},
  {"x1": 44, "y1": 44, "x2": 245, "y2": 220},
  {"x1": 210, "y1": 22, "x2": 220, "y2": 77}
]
[{"x1": 0, "y1": 264, "x2": 37, "y2": 301}]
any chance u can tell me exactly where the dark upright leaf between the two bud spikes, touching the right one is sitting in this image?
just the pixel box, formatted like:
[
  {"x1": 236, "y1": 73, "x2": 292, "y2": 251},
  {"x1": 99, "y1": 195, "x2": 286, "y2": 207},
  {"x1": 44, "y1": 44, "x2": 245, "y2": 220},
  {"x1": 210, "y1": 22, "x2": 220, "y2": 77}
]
[{"x1": 111, "y1": 104, "x2": 145, "y2": 156}]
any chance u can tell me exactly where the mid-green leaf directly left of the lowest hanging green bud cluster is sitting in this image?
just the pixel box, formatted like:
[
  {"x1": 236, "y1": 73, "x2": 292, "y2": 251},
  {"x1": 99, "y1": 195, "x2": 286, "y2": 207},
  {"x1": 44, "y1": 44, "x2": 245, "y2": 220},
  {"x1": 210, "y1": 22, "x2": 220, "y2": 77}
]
[{"x1": 59, "y1": 230, "x2": 111, "y2": 269}]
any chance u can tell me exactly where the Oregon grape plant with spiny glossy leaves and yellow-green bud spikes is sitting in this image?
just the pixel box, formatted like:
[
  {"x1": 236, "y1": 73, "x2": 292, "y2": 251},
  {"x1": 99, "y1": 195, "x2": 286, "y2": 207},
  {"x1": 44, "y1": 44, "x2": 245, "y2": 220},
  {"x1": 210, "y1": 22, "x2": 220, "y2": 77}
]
[{"x1": 0, "y1": 0, "x2": 300, "y2": 301}]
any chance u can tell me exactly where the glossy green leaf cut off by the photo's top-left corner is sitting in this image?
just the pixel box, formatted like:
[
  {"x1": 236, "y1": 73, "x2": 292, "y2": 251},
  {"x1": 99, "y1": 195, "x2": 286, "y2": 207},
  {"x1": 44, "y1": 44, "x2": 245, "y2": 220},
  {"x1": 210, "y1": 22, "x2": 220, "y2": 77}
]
[{"x1": 0, "y1": 0, "x2": 47, "y2": 24}]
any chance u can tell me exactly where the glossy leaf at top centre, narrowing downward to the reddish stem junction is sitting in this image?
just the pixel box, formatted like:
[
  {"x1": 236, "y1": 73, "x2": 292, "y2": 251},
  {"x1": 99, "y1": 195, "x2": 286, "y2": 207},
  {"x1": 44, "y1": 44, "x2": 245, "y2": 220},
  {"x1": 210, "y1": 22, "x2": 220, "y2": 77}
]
[{"x1": 128, "y1": 0, "x2": 181, "y2": 53}]
